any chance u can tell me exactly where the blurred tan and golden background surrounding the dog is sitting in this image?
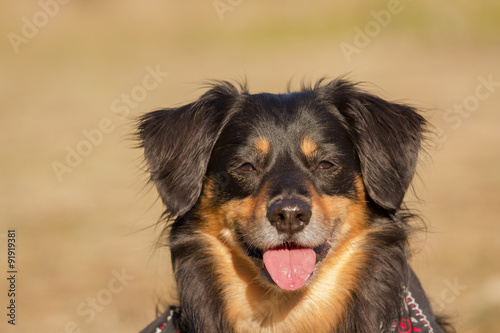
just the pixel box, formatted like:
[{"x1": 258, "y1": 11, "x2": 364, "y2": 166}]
[{"x1": 0, "y1": 0, "x2": 500, "y2": 333}]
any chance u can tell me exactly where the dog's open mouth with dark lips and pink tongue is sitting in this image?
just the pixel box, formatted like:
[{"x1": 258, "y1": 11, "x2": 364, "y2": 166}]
[{"x1": 245, "y1": 239, "x2": 331, "y2": 290}]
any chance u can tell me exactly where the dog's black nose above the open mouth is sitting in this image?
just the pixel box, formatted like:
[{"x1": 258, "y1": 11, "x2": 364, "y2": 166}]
[{"x1": 267, "y1": 198, "x2": 311, "y2": 234}]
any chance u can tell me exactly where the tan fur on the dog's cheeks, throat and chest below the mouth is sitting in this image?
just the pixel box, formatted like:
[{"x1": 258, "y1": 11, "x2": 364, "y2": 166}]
[{"x1": 197, "y1": 184, "x2": 368, "y2": 333}]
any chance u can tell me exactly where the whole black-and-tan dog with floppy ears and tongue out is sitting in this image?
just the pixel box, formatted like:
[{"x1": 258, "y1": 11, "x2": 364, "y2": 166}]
[{"x1": 137, "y1": 78, "x2": 452, "y2": 333}]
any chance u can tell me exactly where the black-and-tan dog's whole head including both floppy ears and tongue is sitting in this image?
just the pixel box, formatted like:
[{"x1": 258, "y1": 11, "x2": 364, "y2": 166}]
[{"x1": 139, "y1": 80, "x2": 424, "y2": 290}]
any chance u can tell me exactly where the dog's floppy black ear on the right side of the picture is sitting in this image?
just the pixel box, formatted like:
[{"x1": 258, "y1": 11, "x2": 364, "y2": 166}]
[{"x1": 319, "y1": 80, "x2": 426, "y2": 210}]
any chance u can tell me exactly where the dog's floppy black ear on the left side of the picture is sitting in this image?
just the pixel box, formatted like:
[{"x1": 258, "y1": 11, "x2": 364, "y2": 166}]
[{"x1": 137, "y1": 82, "x2": 239, "y2": 216}]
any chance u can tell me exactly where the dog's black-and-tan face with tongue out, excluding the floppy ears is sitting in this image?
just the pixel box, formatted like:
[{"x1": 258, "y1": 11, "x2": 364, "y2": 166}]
[{"x1": 201, "y1": 93, "x2": 366, "y2": 290}]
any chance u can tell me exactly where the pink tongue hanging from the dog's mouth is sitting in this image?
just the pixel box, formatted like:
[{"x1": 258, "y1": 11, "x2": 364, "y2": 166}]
[{"x1": 263, "y1": 248, "x2": 316, "y2": 290}]
